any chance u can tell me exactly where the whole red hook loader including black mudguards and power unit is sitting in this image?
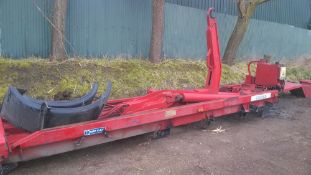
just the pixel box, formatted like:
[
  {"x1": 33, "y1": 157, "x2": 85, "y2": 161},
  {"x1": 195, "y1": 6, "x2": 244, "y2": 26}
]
[{"x1": 0, "y1": 9, "x2": 311, "y2": 174}]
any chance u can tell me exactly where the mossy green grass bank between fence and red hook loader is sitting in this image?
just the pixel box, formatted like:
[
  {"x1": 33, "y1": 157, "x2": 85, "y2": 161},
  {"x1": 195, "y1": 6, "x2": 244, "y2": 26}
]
[{"x1": 0, "y1": 58, "x2": 311, "y2": 99}]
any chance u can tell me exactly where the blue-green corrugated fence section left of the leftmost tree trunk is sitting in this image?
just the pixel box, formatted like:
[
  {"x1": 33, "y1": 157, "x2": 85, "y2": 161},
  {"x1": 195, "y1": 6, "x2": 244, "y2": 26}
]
[{"x1": 0, "y1": 0, "x2": 51, "y2": 58}]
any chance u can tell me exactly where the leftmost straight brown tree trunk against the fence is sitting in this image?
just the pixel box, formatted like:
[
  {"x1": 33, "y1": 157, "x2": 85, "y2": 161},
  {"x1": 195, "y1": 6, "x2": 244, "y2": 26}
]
[{"x1": 50, "y1": 0, "x2": 67, "y2": 61}]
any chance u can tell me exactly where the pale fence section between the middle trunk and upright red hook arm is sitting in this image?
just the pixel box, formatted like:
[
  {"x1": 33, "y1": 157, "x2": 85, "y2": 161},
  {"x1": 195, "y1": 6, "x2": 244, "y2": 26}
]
[{"x1": 163, "y1": 4, "x2": 206, "y2": 58}]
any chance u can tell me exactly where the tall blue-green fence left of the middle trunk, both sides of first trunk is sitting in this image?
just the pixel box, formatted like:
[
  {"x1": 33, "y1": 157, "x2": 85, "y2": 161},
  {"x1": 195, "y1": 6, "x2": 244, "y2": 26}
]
[{"x1": 0, "y1": 0, "x2": 152, "y2": 58}]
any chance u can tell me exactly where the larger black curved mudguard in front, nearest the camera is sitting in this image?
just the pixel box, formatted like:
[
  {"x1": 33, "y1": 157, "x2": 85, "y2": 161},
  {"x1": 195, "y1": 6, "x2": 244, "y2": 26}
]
[{"x1": 1, "y1": 82, "x2": 111, "y2": 132}]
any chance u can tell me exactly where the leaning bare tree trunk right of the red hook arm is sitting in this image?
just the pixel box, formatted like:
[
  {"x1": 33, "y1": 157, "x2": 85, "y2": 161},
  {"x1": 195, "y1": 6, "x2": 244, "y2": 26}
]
[{"x1": 223, "y1": 0, "x2": 269, "y2": 65}]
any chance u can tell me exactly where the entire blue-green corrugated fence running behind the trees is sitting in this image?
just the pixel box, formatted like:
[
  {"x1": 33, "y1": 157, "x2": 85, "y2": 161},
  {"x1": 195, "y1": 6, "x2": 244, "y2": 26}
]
[{"x1": 0, "y1": 0, "x2": 311, "y2": 58}]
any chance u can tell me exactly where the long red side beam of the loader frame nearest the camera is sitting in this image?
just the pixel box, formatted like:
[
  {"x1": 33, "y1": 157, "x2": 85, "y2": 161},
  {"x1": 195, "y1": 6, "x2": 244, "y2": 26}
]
[{"x1": 4, "y1": 91, "x2": 278, "y2": 161}]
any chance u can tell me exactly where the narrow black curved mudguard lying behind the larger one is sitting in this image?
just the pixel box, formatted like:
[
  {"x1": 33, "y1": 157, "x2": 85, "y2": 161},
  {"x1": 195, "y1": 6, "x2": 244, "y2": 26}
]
[{"x1": 22, "y1": 83, "x2": 98, "y2": 108}]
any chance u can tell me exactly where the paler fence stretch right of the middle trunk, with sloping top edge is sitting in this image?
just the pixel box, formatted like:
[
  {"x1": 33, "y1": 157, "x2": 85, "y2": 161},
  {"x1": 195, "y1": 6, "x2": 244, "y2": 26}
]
[{"x1": 164, "y1": 3, "x2": 311, "y2": 59}]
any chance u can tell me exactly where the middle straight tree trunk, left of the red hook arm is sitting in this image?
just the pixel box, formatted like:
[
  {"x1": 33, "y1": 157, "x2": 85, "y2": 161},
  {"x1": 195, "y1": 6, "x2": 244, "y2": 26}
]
[{"x1": 149, "y1": 0, "x2": 165, "y2": 63}]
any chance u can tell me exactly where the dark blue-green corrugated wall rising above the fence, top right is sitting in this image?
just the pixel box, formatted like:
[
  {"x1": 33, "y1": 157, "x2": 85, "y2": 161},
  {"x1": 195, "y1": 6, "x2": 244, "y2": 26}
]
[{"x1": 166, "y1": 0, "x2": 311, "y2": 28}]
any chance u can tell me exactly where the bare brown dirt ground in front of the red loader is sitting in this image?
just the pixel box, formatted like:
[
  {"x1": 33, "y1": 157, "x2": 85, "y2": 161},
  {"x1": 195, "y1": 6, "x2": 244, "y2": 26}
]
[{"x1": 12, "y1": 97, "x2": 311, "y2": 175}]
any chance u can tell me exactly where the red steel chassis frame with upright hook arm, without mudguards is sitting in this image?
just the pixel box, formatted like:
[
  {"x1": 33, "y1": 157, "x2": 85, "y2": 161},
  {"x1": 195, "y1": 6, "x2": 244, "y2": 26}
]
[{"x1": 0, "y1": 10, "x2": 278, "y2": 164}]
